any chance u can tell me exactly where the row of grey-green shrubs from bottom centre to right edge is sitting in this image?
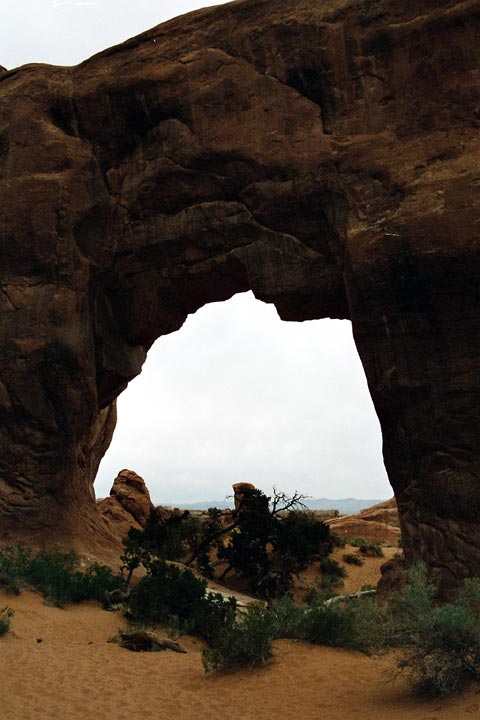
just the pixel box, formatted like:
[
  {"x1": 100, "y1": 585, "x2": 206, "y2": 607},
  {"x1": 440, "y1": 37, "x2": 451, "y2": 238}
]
[{"x1": 204, "y1": 564, "x2": 480, "y2": 696}]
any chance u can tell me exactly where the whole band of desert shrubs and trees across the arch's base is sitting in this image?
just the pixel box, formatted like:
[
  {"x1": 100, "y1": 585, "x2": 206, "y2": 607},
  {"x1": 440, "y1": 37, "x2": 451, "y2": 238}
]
[{"x1": 0, "y1": 492, "x2": 480, "y2": 697}]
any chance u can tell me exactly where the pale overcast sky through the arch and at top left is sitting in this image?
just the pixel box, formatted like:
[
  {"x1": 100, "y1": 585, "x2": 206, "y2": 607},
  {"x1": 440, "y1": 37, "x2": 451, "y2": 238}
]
[{"x1": 0, "y1": 0, "x2": 392, "y2": 504}]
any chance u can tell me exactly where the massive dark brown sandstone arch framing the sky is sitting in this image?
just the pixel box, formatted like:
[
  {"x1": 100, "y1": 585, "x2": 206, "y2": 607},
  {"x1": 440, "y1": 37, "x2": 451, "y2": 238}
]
[{"x1": 0, "y1": 0, "x2": 480, "y2": 585}]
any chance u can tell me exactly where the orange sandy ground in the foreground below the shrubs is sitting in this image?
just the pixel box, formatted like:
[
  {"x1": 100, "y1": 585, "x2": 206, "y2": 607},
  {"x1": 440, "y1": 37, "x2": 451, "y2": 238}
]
[{"x1": 0, "y1": 580, "x2": 480, "y2": 720}]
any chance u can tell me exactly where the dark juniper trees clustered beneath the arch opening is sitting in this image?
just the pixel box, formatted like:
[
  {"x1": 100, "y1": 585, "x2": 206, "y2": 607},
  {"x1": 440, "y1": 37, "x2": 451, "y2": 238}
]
[{"x1": 122, "y1": 488, "x2": 336, "y2": 599}]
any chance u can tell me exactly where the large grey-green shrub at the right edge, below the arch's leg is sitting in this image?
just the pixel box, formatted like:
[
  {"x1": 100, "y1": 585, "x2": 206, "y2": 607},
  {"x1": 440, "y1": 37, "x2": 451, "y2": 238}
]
[{"x1": 342, "y1": 563, "x2": 480, "y2": 697}]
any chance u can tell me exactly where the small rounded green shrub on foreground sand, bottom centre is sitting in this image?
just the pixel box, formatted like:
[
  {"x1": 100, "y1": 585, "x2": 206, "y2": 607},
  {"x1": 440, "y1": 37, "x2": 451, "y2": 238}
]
[{"x1": 202, "y1": 605, "x2": 275, "y2": 672}]
